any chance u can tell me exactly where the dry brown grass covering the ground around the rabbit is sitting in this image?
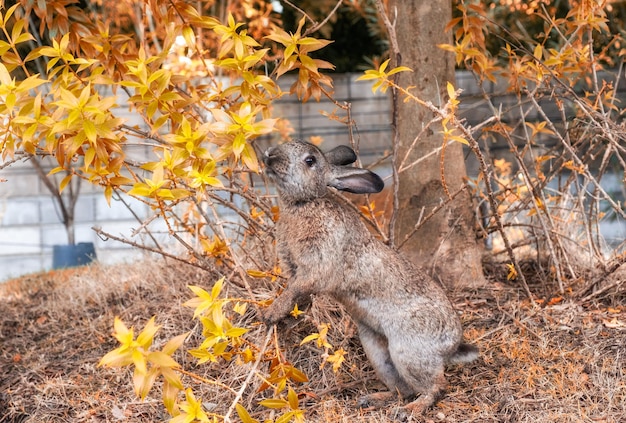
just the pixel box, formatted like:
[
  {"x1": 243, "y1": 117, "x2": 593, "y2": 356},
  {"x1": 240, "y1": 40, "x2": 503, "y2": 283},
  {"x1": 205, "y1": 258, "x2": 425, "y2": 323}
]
[{"x1": 0, "y1": 262, "x2": 626, "y2": 423}]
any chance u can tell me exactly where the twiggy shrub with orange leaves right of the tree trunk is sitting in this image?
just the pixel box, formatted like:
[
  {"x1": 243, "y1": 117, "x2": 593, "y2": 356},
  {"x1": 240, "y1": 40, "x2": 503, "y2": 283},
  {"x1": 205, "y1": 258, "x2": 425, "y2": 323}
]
[{"x1": 442, "y1": 2, "x2": 626, "y2": 301}]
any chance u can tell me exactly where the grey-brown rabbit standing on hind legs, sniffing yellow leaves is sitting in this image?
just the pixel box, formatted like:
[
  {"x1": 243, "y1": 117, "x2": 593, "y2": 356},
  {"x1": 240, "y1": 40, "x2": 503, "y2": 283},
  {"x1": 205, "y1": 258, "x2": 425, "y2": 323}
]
[{"x1": 263, "y1": 141, "x2": 478, "y2": 413}]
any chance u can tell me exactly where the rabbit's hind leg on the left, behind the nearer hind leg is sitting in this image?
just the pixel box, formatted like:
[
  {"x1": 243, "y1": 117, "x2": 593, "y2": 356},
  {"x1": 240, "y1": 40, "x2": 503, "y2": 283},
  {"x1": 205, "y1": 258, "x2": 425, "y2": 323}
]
[{"x1": 358, "y1": 324, "x2": 415, "y2": 408}]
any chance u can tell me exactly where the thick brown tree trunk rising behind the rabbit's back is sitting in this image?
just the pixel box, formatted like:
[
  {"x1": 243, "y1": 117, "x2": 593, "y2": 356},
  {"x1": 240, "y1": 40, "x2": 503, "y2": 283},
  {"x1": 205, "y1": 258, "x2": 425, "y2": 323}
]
[{"x1": 388, "y1": 0, "x2": 484, "y2": 288}]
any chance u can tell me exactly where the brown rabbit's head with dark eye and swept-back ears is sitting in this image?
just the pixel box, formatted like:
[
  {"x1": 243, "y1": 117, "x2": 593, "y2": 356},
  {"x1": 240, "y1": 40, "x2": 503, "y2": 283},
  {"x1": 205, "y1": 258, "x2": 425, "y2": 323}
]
[{"x1": 263, "y1": 141, "x2": 384, "y2": 202}]
